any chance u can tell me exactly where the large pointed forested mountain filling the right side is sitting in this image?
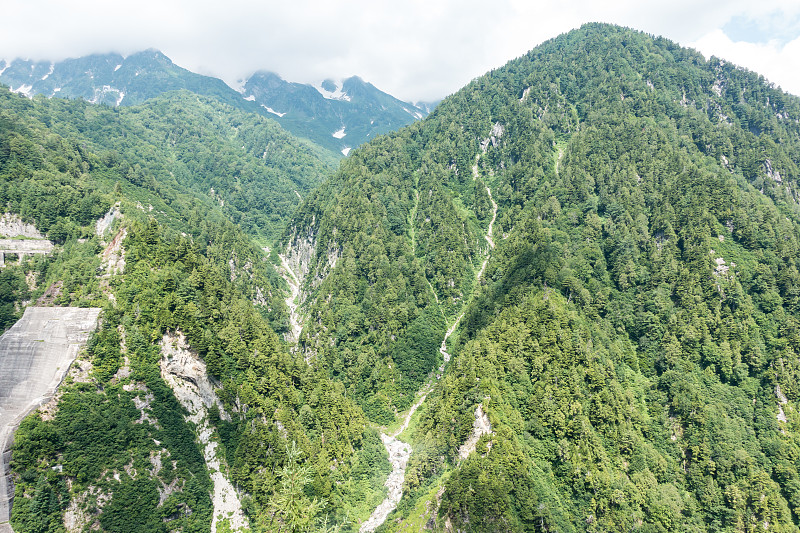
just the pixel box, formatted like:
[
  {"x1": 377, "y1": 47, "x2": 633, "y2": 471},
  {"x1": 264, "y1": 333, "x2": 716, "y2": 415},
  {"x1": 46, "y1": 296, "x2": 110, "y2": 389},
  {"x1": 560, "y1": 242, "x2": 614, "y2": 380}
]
[{"x1": 284, "y1": 24, "x2": 800, "y2": 531}]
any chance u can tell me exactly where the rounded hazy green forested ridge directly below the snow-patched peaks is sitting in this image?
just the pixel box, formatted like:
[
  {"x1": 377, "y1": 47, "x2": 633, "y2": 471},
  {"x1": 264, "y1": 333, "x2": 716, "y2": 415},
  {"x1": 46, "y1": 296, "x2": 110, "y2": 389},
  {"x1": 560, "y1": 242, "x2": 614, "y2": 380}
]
[{"x1": 0, "y1": 91, "x2": 335, "y2": 242}]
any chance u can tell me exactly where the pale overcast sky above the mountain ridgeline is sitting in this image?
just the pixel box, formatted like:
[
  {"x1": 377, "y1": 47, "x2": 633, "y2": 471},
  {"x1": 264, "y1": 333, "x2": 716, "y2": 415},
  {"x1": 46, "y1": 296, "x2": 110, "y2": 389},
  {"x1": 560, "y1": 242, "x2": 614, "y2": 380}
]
[{"x1": 0, "y1": 0, "x2": 800, "y2": 101}]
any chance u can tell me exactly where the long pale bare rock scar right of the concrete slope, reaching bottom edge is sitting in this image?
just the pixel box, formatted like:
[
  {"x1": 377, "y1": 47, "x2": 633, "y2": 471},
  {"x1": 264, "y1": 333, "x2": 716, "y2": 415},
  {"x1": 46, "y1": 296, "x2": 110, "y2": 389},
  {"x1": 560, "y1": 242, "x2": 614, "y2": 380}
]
[{"x1": 160, "y1": 332, "x2": 249, "y2": 533}]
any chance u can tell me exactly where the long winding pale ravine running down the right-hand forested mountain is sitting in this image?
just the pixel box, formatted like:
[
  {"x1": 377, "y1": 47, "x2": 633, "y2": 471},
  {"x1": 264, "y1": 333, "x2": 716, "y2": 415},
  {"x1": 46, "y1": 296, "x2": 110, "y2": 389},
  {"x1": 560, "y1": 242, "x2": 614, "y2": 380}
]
[{"x1": 359, "y1": 154, "x2": 497, "y2": 533}]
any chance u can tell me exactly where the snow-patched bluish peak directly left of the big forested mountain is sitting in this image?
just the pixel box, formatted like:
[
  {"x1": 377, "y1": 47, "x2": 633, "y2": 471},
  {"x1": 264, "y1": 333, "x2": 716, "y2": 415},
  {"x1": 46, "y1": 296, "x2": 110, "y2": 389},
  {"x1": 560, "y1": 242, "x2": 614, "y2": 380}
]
[{"x1": 242, "y1": 72, "x2": 428, "y2": 155}]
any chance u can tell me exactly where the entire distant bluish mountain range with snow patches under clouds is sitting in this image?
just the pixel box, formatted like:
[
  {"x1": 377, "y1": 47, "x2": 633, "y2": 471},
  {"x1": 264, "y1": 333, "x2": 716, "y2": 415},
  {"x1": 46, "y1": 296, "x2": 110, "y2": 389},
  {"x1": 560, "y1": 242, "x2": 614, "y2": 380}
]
[{"x1": 0, "y1": 50, "x2": 427, "y2": 155}]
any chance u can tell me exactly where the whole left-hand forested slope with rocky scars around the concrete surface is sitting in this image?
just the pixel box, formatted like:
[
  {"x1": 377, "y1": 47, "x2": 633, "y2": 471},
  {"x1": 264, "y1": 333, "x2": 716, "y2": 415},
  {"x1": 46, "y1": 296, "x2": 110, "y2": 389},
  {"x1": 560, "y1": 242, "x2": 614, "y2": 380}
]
[{"x1": 0, "y1": 85, "x2": 387, "y2": 532}]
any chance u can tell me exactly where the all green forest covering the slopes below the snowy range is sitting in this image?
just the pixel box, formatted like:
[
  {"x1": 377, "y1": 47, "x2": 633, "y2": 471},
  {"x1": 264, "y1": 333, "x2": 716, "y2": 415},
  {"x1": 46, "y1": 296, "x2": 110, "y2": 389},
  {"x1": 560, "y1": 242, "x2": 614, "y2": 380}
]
[{"x1": 0, "y1": 24, "x2": 800, "y2": 532}]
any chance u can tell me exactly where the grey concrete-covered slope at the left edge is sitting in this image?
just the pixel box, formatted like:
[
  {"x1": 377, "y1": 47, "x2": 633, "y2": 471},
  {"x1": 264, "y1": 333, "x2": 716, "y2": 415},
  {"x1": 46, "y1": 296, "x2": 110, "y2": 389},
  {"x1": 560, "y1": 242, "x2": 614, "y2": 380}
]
[{"x1": 0, "y1": 307, "x2": 100, "y2": 533}]
